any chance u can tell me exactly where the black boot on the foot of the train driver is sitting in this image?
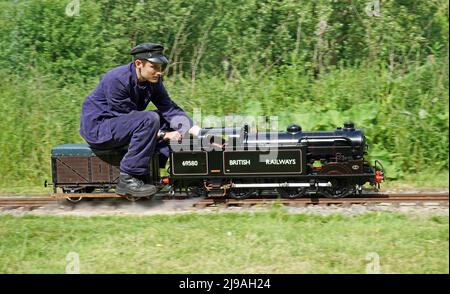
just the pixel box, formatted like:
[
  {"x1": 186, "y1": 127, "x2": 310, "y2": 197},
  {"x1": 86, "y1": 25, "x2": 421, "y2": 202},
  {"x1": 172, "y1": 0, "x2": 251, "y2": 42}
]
[{"x1": 116, "y1": 173, "x2": 158, "y2": 197}]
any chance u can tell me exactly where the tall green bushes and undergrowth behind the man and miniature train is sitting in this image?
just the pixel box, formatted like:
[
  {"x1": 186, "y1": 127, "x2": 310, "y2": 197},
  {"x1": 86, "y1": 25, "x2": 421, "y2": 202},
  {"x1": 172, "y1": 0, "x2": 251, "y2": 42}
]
[{"x1": 0, "y1": 0, "x2": 449, "y2": 188}]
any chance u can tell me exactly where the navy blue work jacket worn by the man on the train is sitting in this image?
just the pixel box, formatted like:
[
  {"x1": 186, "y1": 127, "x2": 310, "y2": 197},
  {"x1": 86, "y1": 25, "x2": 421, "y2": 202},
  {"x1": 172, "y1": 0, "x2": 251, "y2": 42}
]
[{"x1": 80, "y1": 62, "x2": 193, "y2": 144}]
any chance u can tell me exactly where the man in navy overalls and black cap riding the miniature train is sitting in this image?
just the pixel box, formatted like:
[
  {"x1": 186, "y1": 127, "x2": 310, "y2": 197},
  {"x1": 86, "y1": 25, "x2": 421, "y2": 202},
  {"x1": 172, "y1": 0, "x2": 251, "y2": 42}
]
[{"x1": 80, "y1": 43, "x2": 200, "y2": 197}]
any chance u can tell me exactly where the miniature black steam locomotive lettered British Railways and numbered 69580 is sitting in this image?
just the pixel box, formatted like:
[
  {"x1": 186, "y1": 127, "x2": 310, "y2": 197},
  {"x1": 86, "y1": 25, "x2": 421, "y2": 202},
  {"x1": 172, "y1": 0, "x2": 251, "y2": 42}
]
[{"x1": 170, "y1": 123, "x2": 383, "y2": 198}]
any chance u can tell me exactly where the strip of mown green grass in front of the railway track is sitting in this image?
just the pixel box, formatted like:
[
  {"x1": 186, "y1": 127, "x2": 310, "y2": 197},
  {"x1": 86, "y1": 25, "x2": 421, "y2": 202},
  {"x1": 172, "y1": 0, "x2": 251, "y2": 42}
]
[{"x1": 0, "y1": 208, "x2": 449, "y2": 273}]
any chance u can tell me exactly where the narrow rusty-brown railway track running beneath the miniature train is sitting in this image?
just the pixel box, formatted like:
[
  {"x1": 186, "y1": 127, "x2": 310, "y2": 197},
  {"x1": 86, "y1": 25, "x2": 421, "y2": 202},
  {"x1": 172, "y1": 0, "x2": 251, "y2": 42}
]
[{"x1": 0, "y1": 193, "x2": 449, "y2": 208}]
